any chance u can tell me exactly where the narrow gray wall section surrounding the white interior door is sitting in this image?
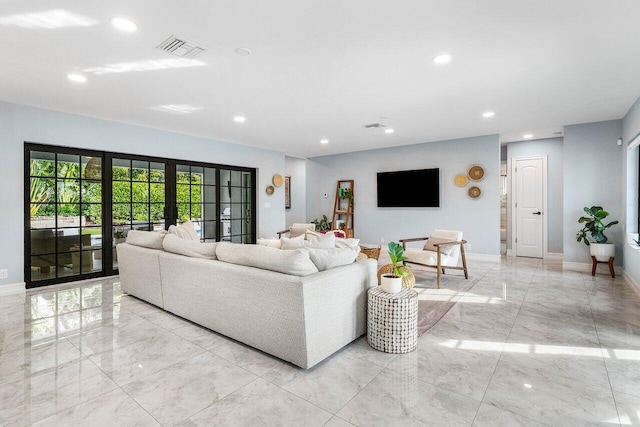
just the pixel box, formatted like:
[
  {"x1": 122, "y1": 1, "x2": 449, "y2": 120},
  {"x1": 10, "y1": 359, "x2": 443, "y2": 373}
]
[{"x1": 507, "y1": 138, "x2": 563, "y2": 253}]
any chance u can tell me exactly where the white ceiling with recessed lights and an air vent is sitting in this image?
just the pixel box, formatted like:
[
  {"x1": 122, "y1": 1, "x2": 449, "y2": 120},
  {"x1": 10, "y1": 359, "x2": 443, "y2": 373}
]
[{"x1": 0, "y1": 0, "x2": 640, "y2": 157}]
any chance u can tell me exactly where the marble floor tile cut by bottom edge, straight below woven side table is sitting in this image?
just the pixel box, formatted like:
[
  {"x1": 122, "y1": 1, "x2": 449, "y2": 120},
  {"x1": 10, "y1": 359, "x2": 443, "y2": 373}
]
[{"x1": 336, "y1": 369, "x2": 480, "y2": 426}]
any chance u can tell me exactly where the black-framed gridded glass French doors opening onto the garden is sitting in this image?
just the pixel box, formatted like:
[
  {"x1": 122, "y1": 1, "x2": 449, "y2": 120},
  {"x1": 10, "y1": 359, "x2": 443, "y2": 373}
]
[{"x1": 25, "y1": 143, "x2": 256, "y2": 288}]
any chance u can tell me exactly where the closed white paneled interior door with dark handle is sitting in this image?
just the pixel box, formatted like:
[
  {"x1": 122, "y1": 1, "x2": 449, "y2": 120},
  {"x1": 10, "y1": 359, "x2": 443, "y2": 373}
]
[{"x1": 512, "y1": 157, "x2": 546, "y2": 258}]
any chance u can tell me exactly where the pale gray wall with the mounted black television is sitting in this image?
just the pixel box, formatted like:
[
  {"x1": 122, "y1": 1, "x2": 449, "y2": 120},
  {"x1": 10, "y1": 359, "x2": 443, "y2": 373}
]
[{"x1": 307, "y1": 135, "x2": 500, "y2": 255}]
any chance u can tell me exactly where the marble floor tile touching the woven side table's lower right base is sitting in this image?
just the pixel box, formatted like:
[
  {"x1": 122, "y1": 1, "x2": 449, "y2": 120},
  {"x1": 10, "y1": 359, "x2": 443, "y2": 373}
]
[{"x1": 387, "y1": 334, "x2": 498, "y2": 401}]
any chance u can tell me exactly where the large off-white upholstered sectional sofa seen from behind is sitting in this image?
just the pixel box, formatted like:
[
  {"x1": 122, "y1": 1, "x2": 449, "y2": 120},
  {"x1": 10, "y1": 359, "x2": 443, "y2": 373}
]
[{"x1": 117, "y1": 232, "x2": 377, "y2": 369}]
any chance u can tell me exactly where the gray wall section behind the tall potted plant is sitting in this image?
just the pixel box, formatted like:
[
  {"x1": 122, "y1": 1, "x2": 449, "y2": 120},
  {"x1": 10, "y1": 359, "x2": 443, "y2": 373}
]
[{"x1": 564, "y1": 120, "x2": 624, "y2": 265}]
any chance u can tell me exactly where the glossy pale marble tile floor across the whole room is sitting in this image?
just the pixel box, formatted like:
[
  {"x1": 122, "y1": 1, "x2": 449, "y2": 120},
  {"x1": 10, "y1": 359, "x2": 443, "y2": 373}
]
[{"x1": 0, "y1": 258, "x2": 640, "y2": 426}]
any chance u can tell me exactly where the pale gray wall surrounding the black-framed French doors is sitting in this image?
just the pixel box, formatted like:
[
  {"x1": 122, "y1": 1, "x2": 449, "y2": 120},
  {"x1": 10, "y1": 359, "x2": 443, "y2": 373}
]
[{"x1": 0, "y1": 102, "x2": 285, "y2": 286}]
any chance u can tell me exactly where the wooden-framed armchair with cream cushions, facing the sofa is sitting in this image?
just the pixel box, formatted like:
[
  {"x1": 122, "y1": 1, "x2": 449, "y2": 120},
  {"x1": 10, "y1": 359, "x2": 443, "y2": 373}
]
[{"x1": 400, "y1": 230, "x2": 469, "y2": 289}]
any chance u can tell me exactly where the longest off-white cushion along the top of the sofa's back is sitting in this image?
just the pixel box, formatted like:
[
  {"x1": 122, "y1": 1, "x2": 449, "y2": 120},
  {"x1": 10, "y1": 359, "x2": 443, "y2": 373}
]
[{"x1": 216, "y1": 242, "x2": 318, "y2": 276}]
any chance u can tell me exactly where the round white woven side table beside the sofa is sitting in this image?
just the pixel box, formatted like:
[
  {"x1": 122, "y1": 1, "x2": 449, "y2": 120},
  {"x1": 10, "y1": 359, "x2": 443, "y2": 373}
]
[{"x1": 367, "y1": 286, "x2": 418, "y2": 353}]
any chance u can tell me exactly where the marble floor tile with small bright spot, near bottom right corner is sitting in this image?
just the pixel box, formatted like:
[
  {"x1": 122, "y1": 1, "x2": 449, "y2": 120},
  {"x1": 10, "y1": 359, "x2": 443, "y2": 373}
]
[{"x1": 483, "y1": 361, "x2": 618, "y2": 426}]
